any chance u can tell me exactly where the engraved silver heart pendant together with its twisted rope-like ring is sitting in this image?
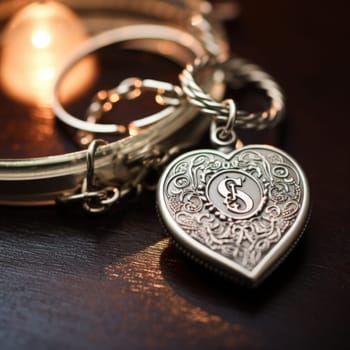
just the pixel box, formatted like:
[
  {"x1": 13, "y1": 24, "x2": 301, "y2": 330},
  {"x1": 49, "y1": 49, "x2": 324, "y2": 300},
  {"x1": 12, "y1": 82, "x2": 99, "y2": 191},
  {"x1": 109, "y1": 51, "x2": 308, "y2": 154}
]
[{"x1": 157, "y1": 59, "x2": 310, "y2": 286}]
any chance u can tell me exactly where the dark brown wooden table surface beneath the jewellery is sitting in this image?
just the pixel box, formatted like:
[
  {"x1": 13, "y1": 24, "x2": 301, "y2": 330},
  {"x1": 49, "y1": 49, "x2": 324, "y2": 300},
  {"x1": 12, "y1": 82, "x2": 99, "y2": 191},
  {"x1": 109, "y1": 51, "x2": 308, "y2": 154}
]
[{"x1": 0, "y1": 0, "x2": 350, "y2": 350}]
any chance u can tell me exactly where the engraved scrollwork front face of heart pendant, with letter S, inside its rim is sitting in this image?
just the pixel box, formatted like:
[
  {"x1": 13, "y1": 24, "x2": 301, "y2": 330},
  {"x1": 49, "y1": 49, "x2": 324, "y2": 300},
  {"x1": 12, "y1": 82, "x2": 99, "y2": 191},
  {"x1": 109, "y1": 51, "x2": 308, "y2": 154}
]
[{"x1": 162, "y1": 146, "x2": 304, "y2": 271}]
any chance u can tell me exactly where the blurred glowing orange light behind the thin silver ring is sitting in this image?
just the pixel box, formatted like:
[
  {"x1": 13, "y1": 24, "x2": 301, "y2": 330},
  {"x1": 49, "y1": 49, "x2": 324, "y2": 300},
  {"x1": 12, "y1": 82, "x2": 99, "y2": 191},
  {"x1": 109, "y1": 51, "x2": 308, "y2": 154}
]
[{"x1": 0, "y1": 1, "x2": 95, "y2": 106}]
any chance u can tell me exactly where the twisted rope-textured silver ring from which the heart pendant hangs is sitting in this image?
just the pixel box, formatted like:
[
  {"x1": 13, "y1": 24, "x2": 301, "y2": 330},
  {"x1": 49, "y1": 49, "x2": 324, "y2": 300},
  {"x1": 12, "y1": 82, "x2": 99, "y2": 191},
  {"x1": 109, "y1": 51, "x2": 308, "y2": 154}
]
[{"x1": 179, "y1": 57, "x2": 285, "y2": 130}]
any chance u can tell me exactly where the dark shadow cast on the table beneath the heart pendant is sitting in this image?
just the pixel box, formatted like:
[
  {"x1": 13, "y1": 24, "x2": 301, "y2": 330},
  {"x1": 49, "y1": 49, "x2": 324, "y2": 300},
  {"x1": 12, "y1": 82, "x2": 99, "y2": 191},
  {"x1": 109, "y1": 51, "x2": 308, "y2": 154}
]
[{"x1": 160, "y1": 231, "x2": 307, "y2": 316}]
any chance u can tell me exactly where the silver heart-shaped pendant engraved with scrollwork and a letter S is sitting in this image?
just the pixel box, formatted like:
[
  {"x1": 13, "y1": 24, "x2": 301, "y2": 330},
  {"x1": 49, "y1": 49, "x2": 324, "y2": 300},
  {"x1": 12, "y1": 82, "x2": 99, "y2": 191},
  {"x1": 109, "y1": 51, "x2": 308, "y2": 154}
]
[{"x1": 157, "y1": 145, "x2": 310, "y2": 286}]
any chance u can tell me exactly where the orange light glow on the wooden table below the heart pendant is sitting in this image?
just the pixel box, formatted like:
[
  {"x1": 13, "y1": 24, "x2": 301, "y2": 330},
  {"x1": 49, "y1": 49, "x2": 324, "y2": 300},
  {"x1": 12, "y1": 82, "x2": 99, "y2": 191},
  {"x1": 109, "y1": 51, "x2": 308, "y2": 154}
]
[{"x1": 104, "y1": 239, "x2": 249, "y2": 349}]
